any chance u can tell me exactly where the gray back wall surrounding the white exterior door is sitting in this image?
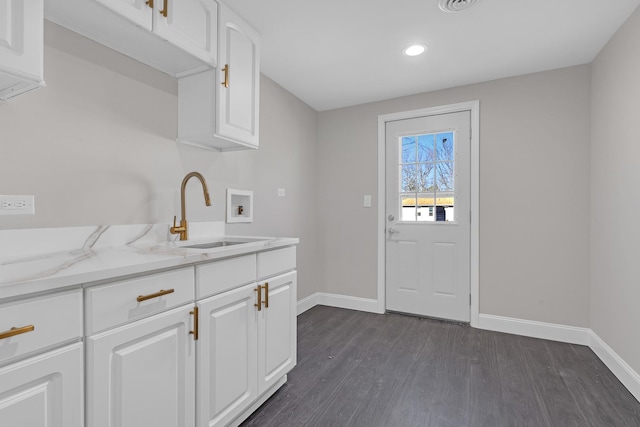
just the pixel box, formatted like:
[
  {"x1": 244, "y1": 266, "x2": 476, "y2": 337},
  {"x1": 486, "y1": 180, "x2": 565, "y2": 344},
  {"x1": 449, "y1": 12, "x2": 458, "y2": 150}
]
[{"x1": 318, "y1": 65, "x2": 590, "y2": 327}]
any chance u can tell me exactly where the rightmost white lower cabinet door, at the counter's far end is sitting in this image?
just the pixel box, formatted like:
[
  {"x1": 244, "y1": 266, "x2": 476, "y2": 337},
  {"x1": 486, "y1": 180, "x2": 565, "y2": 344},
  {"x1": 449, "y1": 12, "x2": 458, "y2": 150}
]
[{"x1": 258, "y1": 271, "x2": 297, "y2": 395}]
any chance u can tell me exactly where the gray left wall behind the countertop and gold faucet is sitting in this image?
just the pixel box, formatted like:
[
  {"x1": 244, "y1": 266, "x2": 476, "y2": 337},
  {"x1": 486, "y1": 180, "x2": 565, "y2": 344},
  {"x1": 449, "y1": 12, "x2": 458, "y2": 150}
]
[{"x1": 0, "y1": 22, "x2": 317, "y2": 298}]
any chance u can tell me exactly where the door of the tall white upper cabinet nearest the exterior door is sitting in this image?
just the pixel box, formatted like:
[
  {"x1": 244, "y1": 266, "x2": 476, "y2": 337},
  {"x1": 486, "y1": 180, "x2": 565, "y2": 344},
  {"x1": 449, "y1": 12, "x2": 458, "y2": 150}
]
[{"x1": 216, "y1": 5, "x2": 260, "y2": 147}]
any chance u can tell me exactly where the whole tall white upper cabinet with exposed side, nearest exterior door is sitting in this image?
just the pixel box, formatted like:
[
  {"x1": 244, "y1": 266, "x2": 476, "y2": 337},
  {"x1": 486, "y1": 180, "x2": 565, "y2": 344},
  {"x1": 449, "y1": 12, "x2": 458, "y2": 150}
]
[{"x1": 178, "y1": 3, "x2": 260, "y2": 151}]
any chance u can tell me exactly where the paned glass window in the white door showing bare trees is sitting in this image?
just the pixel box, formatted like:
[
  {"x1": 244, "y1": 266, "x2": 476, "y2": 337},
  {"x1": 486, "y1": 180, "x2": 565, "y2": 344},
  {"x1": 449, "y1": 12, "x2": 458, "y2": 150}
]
[{"x1": 398, "y1": 131, "x2": 455, "y2": 222}]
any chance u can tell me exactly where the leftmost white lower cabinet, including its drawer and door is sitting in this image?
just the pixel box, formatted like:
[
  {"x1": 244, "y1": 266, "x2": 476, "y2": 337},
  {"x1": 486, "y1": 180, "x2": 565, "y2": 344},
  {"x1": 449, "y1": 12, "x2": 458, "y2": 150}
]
[{"x1": 0, "y1": 288, "x2": 84, "y2": 427}]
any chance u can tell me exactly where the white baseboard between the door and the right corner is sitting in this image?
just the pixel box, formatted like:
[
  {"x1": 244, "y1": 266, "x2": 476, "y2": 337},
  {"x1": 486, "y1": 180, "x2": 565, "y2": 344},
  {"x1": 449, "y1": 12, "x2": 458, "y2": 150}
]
[{"x1": 477, "y1": 314, "x2": 591, "y2": 345}]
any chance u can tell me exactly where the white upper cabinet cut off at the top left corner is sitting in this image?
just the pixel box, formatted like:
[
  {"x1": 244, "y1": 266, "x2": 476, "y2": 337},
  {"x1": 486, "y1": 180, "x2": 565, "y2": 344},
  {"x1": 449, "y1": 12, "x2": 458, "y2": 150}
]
[{"x1": 0, "y1": 0, "x2": 44, "y2": 100}]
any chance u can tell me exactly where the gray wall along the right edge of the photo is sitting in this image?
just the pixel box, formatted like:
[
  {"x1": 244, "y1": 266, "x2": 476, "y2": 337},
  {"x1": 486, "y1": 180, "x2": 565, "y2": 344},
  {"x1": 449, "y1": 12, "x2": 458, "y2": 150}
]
[{"x1": 591, "y1": 9, "x2": 640, "y2": 372}]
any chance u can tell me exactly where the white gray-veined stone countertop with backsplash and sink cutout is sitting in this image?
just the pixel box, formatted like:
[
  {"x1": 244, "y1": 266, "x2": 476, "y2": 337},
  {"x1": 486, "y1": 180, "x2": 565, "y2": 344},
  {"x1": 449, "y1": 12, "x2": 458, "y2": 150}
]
[{"x1": 0, "y1": 225, "x2": 299, "y2": 301}]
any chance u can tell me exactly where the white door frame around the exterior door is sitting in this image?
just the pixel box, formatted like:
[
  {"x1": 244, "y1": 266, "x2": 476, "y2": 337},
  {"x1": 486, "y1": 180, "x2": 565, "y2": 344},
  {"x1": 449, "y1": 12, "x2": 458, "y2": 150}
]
[{"x1": 378, "y1": 100, "x2": 480, "y2": 327}]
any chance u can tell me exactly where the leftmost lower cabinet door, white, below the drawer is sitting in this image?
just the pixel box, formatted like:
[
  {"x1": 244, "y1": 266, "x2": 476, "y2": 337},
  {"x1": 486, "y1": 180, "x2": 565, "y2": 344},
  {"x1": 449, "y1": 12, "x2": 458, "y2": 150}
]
[{"x1": 0, "y1": 343, "x2": 84, "y2": 427}]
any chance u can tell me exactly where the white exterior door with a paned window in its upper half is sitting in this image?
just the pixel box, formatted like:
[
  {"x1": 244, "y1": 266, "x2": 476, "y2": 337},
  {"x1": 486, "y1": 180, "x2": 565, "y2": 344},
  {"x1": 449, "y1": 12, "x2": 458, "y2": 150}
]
[{"x1": 385, "y1": 111, "x2": 471, "y2": 322}]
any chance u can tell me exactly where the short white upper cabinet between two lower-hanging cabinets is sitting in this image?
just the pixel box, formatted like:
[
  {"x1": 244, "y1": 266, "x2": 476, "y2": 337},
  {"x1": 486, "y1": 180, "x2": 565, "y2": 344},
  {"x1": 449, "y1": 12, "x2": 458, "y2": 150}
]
[{"x1": 45, "y1": 0, "x2": 218, "y2": 77}]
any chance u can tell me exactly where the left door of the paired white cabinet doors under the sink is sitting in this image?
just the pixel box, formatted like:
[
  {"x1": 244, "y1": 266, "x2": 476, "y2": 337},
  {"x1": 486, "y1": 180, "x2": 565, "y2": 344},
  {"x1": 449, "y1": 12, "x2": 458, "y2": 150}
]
[{"x1": 197, "y1": 283, "x2": 257, "y2": 426}]
